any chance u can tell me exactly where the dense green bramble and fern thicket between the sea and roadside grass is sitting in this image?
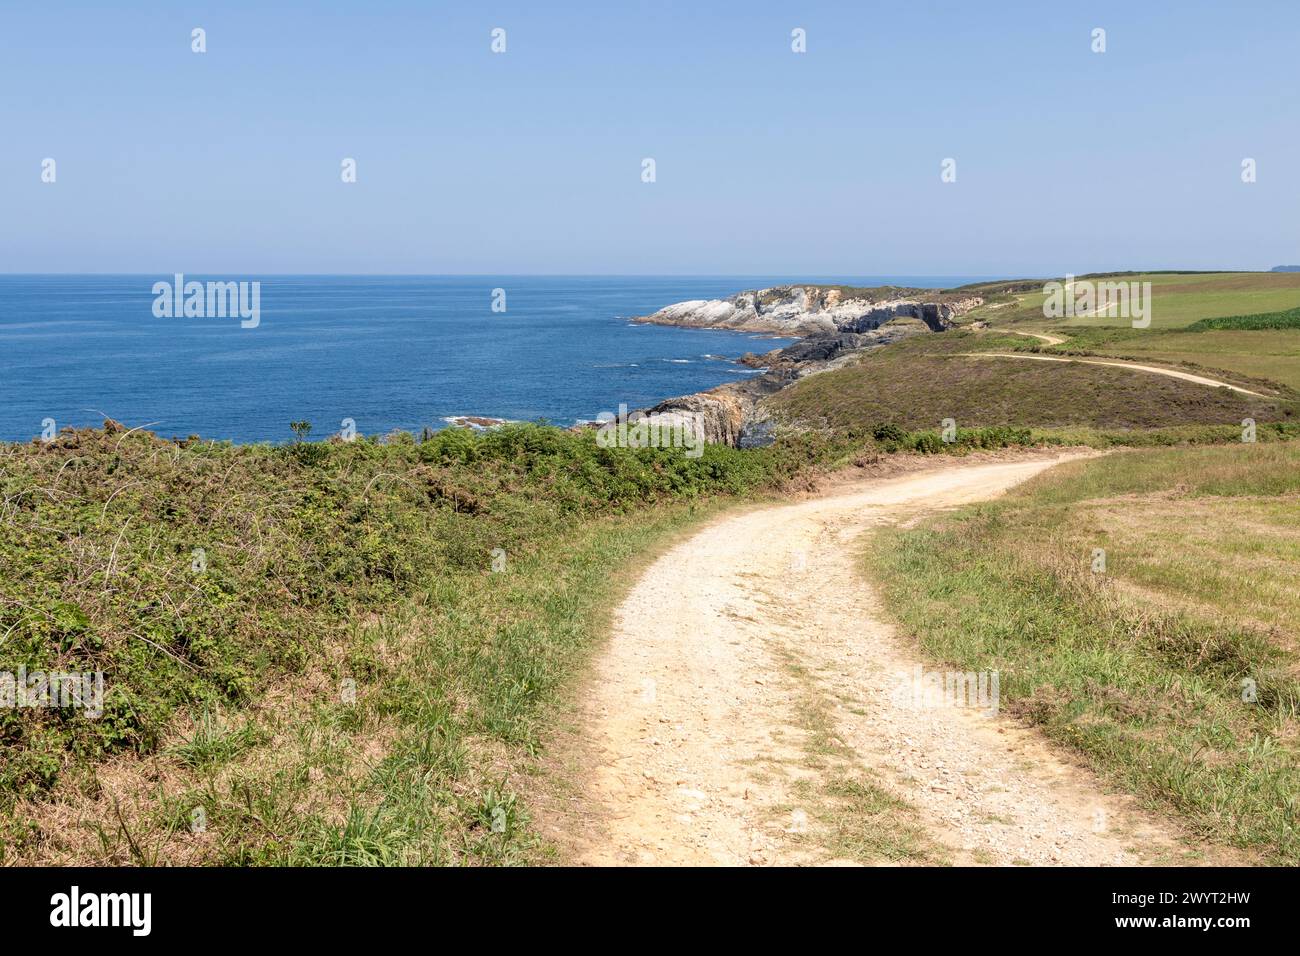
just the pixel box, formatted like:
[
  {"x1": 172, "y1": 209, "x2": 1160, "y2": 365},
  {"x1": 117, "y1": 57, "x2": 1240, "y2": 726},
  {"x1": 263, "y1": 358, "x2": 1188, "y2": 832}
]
[{"x1": 0, "y1": 423, "x2": 848, "y2": 808}]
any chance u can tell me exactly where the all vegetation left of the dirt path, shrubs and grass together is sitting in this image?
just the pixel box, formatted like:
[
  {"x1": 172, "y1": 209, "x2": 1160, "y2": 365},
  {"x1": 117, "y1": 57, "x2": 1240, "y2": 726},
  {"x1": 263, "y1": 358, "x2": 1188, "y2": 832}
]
[{"x1": 0, "y1": 427, "x2": 837, "y2": 864}]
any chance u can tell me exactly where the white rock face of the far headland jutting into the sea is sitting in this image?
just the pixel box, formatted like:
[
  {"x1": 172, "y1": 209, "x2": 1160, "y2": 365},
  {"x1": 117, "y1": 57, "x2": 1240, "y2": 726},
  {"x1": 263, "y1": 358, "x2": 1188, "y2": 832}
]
[{"x1": 640, "y1": 286, "x2": 982, "y2": 336}]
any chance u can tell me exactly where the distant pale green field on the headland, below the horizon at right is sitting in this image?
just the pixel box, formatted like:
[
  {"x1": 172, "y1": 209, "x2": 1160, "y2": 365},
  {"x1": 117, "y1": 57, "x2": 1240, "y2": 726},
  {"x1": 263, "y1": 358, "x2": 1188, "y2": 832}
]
[{"x1": 965, "y1": 272, "x2": 1300, "y2": 329}]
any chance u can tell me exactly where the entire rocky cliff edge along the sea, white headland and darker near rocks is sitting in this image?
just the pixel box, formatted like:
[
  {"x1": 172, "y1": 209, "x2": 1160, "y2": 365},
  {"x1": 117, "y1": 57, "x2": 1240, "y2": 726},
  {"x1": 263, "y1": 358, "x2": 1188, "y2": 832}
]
[{"x1": 636, "y1": 285, "x2": 983, "y2": 447}]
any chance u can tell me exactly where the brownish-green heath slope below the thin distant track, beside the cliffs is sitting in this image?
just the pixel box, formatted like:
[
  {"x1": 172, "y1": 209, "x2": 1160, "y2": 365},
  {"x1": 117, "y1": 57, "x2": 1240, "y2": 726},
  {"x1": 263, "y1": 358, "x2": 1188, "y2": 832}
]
[{"x1": 768, "y1": 332, "x2": 1294, "y2": 429}]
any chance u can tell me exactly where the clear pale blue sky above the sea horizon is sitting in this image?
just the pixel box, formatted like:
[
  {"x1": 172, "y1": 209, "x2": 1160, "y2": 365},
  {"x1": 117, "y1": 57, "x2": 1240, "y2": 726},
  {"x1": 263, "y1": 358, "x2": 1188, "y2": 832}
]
[{"x1": 0, "y1": 0, "x2": 1300, "y2": 276}]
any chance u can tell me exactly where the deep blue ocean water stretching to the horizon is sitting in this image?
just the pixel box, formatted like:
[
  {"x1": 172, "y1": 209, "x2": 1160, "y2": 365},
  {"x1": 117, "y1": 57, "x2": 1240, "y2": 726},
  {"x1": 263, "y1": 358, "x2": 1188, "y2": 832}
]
[{"x1": 0, "y1": 274, "x2": 970, "y2": 442}]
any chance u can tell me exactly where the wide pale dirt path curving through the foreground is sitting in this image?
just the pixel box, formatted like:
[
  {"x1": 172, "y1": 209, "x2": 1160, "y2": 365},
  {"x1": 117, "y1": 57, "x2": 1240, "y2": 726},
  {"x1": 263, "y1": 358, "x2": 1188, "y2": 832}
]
[{"x1": 562, "y1": 458, "x2": 1216, "y2": 865}]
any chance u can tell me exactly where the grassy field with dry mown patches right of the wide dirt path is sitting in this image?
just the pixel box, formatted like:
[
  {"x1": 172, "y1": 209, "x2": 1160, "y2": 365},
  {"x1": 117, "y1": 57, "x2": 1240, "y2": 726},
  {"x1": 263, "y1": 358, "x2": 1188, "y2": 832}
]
[{"x1": 868, "y1": 444, "x2": 1300, "y2": 865}]
